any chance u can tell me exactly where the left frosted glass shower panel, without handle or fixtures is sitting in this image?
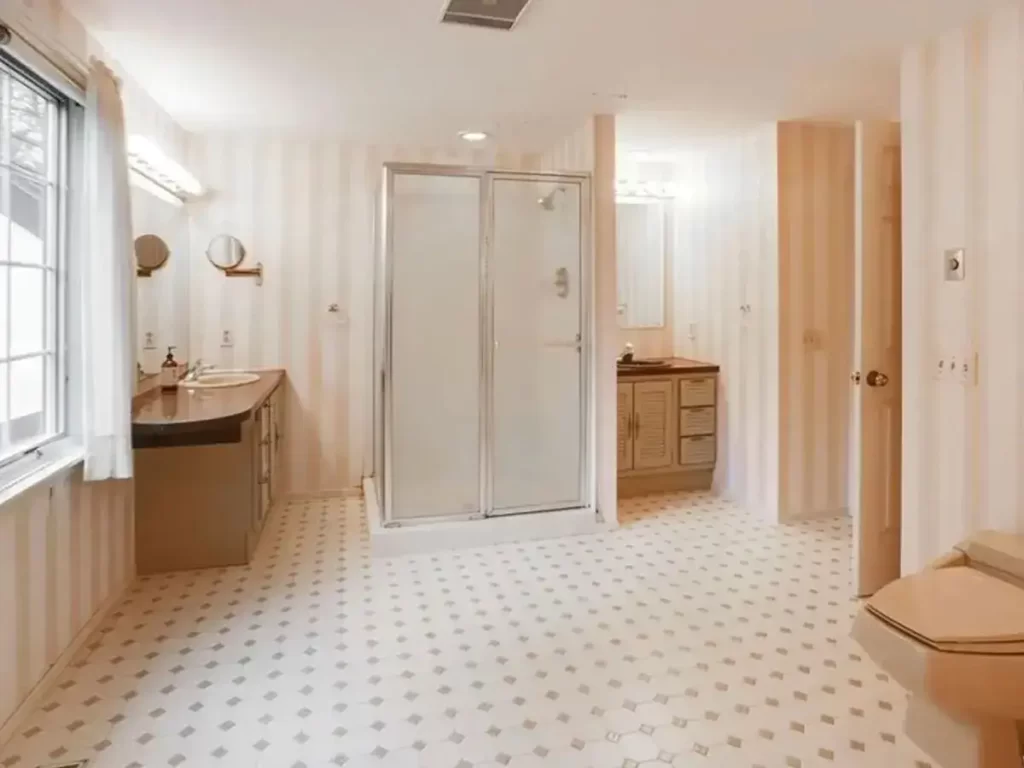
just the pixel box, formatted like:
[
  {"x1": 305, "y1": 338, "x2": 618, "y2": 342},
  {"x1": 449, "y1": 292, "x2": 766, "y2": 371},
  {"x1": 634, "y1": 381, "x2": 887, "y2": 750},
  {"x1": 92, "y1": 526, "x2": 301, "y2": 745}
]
[{"x1": 385, "y1": 173, "x2": 482, "y2": 521}]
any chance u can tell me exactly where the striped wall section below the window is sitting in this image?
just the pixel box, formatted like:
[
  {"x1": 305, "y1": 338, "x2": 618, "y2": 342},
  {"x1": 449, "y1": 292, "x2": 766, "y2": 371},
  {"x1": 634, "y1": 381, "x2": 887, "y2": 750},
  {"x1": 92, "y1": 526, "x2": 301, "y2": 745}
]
[{"x1": 0, "y1": 471, "x2": 135, "y2": 732}]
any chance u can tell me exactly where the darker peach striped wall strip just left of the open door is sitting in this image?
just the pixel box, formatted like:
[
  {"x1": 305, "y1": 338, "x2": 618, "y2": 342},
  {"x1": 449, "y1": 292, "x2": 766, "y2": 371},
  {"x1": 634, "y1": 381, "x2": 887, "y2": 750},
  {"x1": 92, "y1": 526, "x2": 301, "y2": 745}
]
[{"x1": 778, "y1": 123, "x2": 855, "y2": 518}]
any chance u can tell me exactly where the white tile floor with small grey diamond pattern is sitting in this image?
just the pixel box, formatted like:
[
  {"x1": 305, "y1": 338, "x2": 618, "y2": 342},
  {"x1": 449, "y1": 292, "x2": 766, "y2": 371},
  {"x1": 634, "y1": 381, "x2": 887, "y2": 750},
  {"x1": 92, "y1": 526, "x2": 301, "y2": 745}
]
[{"x1": 0, "y1": 495, "x2": 928, "y2": 768}]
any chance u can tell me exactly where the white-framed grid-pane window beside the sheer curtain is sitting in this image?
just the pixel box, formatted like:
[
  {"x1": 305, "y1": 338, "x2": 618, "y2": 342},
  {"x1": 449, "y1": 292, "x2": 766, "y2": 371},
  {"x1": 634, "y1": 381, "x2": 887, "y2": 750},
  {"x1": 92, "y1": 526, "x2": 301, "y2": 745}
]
[{"x1": 0, "y1": 57, "x2": 68, "y2": 466}]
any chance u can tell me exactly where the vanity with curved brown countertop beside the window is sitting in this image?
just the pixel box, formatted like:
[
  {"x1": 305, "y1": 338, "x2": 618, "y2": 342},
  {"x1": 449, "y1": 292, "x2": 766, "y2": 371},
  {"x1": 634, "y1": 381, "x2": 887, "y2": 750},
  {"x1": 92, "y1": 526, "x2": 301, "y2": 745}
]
[{"x1": 133, "y1": 372, "x2": 285, "y2": 574}]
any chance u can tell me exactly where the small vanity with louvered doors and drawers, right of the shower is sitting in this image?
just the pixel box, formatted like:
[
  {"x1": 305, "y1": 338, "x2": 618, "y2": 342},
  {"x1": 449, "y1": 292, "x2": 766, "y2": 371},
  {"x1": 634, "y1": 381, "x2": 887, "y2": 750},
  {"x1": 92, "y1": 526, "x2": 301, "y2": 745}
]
[{"x1": 617, "y1": 360, "x2": 718, "y2": 497}]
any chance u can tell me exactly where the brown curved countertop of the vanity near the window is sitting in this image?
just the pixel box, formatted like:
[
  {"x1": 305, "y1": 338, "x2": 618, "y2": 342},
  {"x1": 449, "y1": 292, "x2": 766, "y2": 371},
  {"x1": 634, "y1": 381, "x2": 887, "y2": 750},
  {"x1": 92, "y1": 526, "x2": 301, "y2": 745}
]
[{"x1": 131, "y1": 371, "x2": 285, "y2": 447}]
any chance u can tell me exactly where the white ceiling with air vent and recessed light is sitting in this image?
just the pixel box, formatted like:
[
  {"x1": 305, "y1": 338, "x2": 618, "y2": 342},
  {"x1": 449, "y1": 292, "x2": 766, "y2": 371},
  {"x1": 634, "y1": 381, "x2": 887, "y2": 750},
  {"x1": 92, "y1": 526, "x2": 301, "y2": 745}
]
[{"x1": 66, "y1": 0, "x2": 1002, "y2": 150}]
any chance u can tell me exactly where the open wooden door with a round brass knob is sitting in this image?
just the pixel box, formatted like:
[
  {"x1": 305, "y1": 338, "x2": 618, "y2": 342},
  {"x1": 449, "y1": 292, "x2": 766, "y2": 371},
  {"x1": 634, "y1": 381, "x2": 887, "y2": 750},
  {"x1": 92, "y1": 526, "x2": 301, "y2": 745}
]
[{"x1": 851, "y1": 123, "x2": 902, "y2": 596}]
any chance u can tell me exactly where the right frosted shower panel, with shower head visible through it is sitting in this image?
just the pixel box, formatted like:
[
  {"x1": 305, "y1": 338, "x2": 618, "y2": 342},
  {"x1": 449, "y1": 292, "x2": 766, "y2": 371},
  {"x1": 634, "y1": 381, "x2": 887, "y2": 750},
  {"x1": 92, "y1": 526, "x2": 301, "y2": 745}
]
[{"x1": 490, "y1": 176, "x2": 586, "y2": 515}]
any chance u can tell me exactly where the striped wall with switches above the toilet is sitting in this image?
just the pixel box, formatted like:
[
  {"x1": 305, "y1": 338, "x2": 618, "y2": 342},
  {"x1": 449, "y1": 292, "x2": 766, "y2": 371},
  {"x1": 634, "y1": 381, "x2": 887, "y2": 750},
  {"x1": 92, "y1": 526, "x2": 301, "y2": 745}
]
[{"x1": 901, "y1": 3, "x2": 1024, "y2": 572}]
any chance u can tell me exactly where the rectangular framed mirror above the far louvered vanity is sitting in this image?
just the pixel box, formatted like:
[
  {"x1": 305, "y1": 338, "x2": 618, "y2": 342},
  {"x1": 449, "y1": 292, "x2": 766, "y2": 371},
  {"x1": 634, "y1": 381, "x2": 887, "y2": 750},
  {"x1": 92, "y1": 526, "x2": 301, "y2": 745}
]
[{"x1": 615, "y1": 197, "x2": 669, "y2": 329}]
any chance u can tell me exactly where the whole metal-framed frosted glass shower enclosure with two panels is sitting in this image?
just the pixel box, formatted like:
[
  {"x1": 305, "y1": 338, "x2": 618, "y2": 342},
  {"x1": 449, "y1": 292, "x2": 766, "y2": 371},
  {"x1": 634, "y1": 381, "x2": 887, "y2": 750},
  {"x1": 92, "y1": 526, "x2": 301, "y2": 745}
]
[{"x1": 373, "y1": 164, "x2": 594, "y2": 528}]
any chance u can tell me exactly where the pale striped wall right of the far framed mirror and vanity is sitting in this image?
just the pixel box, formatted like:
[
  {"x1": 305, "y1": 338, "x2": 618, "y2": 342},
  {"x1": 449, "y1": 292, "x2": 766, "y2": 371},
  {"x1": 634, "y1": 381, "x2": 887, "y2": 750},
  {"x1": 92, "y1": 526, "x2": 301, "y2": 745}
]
[{"x1": 672, "y1": 124, "x2": 779, "y2": 519}]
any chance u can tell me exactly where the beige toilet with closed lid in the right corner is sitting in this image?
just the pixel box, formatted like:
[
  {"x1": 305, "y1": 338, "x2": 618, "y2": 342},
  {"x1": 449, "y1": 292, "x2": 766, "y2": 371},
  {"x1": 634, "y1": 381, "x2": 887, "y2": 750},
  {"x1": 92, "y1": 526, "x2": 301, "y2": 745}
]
[{"x1": 852, "y1": 531, "x2": 1024, "y2": 768}]
